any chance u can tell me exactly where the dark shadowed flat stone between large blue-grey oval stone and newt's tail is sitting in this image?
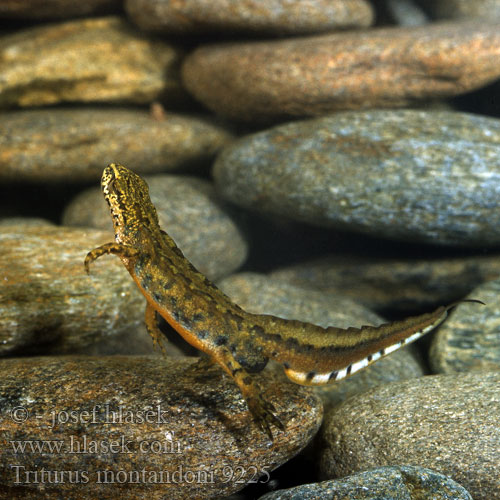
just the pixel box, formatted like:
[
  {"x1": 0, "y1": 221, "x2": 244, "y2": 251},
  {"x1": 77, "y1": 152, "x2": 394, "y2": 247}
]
[{"x1": 271, "y1": 254, "x2": 500, "y2": 314}]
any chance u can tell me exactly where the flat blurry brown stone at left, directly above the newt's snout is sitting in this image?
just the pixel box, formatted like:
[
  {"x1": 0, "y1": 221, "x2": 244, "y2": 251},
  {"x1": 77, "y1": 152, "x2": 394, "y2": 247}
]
[{"x1": 0, "y1": 108, "x2": 231, "y2": 182}]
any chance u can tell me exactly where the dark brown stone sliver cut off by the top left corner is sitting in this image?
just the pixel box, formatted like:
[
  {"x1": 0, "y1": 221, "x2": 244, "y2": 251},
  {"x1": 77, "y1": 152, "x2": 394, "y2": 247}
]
[{"x1": 0, "y1": 0, "x2": 120, "y2": 19}]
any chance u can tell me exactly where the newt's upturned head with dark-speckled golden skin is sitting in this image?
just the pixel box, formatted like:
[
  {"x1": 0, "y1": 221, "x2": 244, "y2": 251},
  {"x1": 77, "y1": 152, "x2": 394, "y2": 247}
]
[{"x1": 101, "y1": 163, "x2": 159, "y2": 243}]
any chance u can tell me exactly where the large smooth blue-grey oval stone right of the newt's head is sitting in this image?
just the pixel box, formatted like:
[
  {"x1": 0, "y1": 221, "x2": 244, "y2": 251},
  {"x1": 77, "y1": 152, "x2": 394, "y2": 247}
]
[{"x1": 214, "y1": 111, "x2": 500, "y2": 247}]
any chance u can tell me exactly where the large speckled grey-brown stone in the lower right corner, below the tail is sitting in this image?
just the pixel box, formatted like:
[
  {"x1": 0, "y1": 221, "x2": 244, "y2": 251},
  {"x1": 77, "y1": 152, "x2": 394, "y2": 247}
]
[{"x1": 321, "y1": 372, "x2": 500, "y2": 500}]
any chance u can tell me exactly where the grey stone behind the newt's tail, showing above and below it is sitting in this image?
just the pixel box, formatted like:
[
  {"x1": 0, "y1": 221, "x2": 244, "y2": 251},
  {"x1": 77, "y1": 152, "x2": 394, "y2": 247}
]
[{"x1": 219, "y1": 273, "x2": 424, "y2": 411}]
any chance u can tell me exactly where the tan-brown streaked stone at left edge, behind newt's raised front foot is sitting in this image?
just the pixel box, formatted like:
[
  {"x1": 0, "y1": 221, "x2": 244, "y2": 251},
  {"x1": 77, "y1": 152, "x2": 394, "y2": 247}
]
[{"x1": 0, "y1": 226, "x2": 145, "y2": 354}]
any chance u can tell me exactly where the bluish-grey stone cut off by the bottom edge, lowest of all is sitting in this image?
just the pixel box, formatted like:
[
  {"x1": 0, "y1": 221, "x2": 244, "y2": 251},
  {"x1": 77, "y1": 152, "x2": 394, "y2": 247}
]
[{"x1": 260, "y1": 465, "x2": 472, "y2": 500}]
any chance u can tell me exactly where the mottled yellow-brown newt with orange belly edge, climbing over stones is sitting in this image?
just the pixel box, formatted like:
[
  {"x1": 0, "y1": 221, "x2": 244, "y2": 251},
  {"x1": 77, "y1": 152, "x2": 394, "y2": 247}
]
[{"x1": 84, "y1": 163, "x2": 479, "y2": 440}]
